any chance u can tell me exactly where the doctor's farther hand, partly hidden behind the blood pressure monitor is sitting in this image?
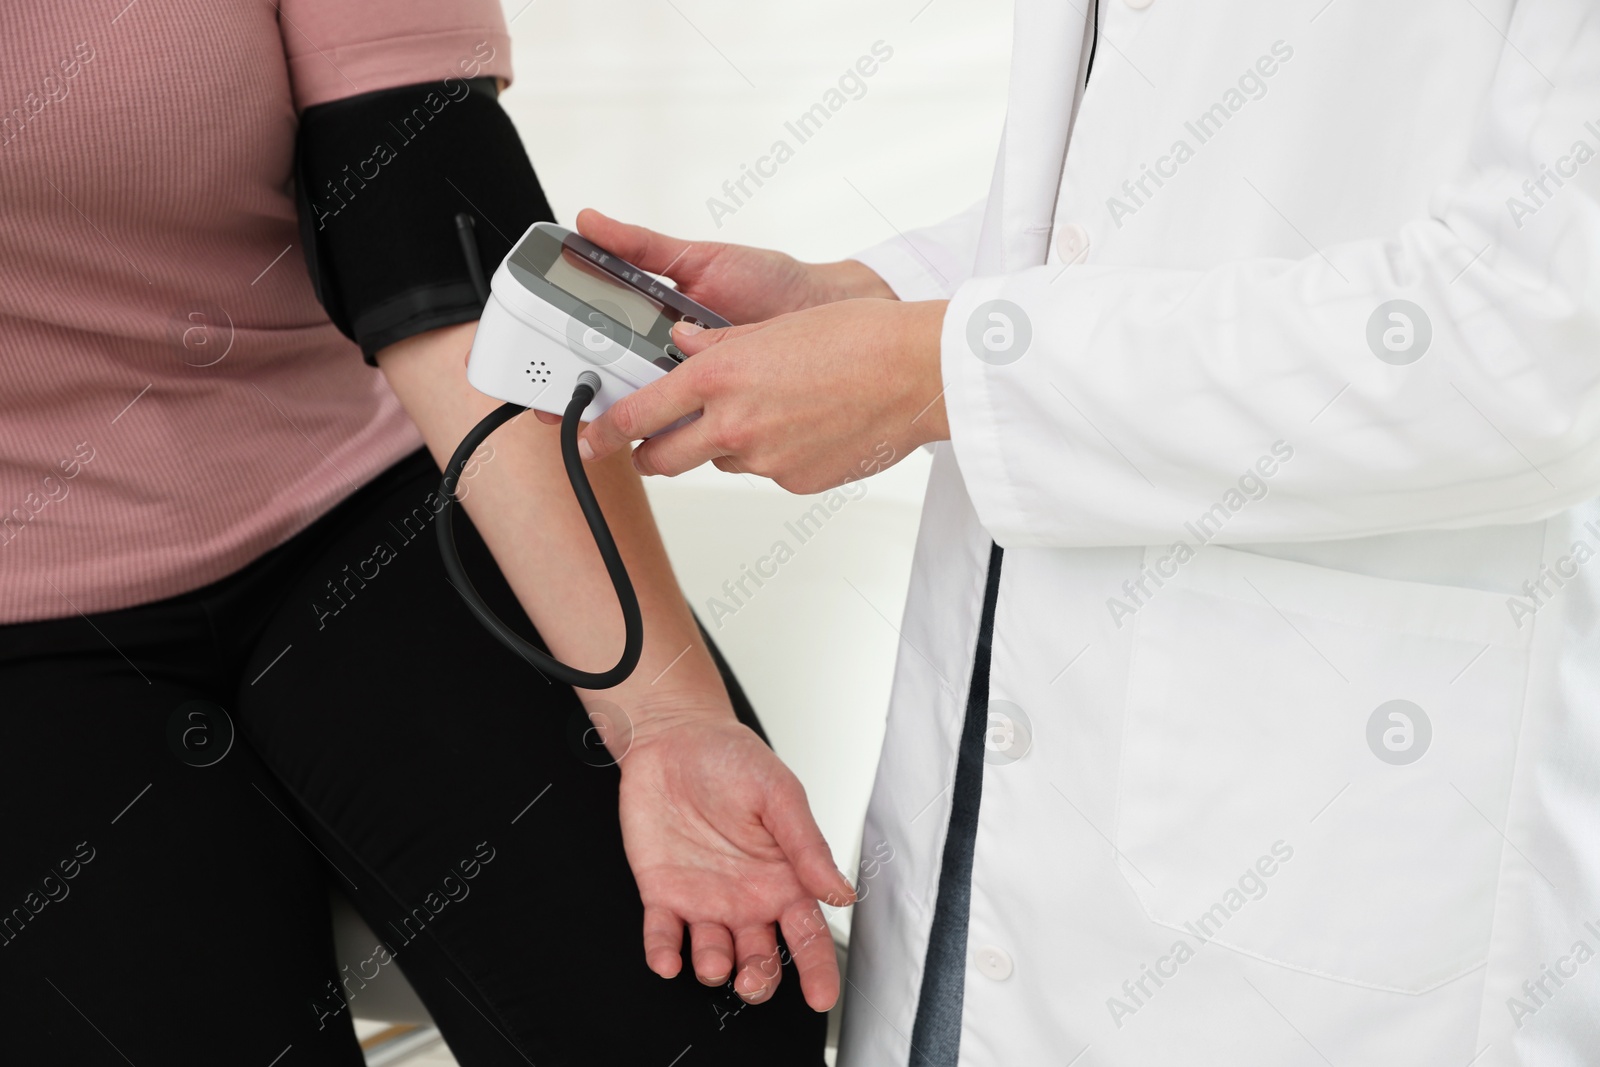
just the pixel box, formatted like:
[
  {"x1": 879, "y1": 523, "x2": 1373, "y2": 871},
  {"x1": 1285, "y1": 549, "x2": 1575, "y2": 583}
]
[{"x1": 578, "y1": 208, "x2": 894, "y2": 323}]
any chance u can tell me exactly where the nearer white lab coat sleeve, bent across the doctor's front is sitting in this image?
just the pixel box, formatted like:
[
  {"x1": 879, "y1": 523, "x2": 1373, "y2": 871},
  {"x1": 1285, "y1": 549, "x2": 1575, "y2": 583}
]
[{"x1": 941, "y1": 10, "x2": 1600, "y2": 547}]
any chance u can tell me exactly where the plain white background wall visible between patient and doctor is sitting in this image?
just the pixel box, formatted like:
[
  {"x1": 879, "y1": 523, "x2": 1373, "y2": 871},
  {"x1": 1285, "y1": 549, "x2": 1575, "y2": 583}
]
[{"x1": 502, "y1": 0, "x2": 1011, "y2": 927}]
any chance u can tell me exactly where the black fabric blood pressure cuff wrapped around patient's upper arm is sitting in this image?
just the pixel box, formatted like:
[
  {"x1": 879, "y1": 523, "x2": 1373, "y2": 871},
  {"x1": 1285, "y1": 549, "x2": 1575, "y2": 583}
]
[{"x1": 294, "y1": 77, "x2": 554, "y2": 366}]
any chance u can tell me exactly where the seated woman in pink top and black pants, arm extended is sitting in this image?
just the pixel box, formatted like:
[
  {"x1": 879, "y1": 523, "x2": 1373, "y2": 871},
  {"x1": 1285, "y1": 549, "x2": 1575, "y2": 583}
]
[{"x1": 0, "y1": 0, "x2": 851, "y2": 1067}]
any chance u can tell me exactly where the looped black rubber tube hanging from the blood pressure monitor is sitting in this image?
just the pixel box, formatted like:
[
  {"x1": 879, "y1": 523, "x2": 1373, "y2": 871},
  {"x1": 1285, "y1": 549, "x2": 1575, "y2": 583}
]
[{"x1": 435, "y1": 379, "x2": 645, "y2": 689}]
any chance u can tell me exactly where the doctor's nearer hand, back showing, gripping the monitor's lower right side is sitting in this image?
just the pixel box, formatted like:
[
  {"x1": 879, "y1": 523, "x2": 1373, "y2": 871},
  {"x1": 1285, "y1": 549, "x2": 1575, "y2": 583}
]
[{"x1": 578, "y1": 299, "x2": 949, "y2": 493}]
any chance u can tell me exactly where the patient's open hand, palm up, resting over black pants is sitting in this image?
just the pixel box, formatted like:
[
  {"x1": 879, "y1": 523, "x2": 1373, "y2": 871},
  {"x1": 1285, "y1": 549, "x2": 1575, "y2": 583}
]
[{"x1": 619, "y1": 717, "x2": 854, "y2": 1011}]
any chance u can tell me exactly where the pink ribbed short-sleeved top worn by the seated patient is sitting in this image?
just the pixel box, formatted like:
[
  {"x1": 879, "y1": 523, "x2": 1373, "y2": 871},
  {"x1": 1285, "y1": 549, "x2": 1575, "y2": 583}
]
[{"x1": 0, "y1": 0, "x2": 510, "y2": 622}]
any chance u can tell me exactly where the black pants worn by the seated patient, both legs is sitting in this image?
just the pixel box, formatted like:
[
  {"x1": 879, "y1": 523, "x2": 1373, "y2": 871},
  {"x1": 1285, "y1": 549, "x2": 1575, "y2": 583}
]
[{"x1": 0, "y1": 451, "x2": 824, "y2": 1067}]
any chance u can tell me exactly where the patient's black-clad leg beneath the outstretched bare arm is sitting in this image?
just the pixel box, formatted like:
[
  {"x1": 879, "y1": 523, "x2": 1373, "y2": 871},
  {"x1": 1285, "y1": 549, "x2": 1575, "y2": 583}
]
[{"x1": 238, "y1": 460, "x2": 824, "y2": 1067}]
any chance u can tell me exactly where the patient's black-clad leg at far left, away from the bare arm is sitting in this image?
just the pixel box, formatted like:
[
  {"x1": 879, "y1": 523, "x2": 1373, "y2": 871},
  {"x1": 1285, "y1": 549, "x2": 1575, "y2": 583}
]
[{"x1": 0, "y1": 605, "x2": 362, "y2": 1067}]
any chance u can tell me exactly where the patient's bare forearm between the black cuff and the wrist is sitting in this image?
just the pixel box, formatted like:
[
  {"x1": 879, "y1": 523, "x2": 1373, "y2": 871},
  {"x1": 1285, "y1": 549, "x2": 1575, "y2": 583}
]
[{"x1": 378, "y1": 323, "x2": 731, "y2": 747}]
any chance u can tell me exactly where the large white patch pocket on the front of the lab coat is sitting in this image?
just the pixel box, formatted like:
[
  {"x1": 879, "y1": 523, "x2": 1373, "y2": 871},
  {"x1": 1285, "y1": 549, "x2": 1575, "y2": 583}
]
[{"x1": 1115, "y1": 545, "x2": 1538, "y2": 993}]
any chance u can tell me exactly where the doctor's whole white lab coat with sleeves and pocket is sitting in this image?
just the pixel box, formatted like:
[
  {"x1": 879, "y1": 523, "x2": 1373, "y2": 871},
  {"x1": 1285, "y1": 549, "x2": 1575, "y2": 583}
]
[{"x1": 840, "y1": 0, "x2": 1600, "y2": 1067}]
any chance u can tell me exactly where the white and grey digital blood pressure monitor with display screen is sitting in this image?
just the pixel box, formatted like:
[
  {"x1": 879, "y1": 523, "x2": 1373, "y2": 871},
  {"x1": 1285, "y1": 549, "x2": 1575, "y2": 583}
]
[{"x1": 467, "y1": 222, "x2": 730, "y2": 421}]
